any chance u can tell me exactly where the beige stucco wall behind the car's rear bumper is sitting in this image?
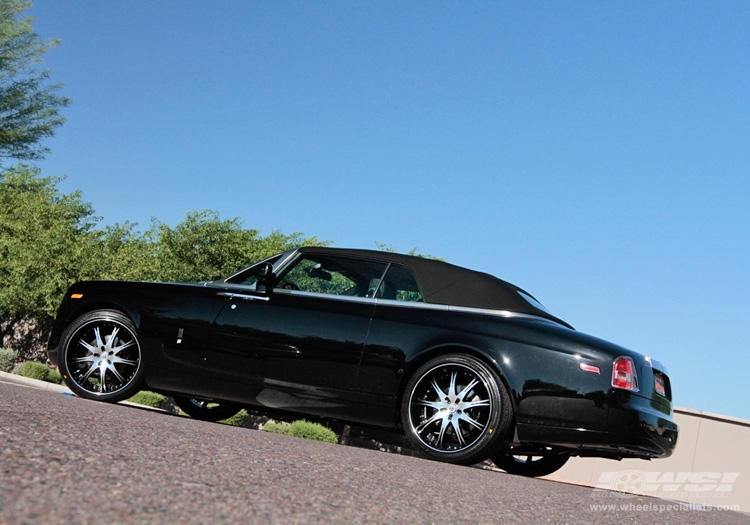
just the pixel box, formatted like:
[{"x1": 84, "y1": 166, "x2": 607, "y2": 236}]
[{"x1": 548, "y1": 408, "x2": 750, "y2": 512}]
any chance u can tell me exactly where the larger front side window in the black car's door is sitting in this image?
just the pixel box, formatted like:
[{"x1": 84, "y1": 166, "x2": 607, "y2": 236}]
[{"x1": 276, "y1": 254, "x2": 386, "y2": 297}]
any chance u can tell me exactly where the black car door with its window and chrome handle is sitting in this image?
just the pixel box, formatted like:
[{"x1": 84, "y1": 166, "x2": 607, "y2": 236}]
[{"x1": 209, "y1": 253, "x2": 386, "y2": 400}]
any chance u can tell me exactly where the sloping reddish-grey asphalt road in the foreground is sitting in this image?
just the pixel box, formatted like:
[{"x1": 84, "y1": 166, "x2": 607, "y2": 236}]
[{"x1": 0, "y1": 383, "x2": 750, "y2": 525}]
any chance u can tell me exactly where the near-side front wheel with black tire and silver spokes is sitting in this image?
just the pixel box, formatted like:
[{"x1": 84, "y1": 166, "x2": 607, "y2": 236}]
[{"x1": 60, "y1": 310, "x2": 143, "y2": 403}]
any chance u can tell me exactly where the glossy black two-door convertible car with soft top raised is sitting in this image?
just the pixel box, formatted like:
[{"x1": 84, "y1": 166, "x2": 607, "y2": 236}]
[{"x1": 49, "y1": 247, "x2": 678, "y2": 476}]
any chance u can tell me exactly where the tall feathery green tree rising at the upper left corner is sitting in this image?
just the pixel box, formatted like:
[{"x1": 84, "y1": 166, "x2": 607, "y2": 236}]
[{"x1": 0, "y1": 0, "x2": 70, "y2": 160}]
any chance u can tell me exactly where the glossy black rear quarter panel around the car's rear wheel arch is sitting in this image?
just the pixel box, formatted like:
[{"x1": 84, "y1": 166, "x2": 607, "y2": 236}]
[{"x1": 358, "y1": 303, "x2": 638, "y2": 431}]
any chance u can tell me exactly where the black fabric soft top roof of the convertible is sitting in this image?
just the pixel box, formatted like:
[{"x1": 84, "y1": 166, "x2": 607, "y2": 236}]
[{"x1": 299, "y1": 247, "x2": 570, "y2": 327}]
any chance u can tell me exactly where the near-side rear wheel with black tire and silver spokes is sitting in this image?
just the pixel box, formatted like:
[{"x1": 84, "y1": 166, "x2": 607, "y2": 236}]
[{"x1": 401, "y1": 354, "x2": 513, "y2": 465}]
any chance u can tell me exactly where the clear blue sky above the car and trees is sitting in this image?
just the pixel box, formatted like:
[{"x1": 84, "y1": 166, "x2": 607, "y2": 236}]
[{"x1": 31, "y1": 0, "x2": 750, "y2": 419}]
